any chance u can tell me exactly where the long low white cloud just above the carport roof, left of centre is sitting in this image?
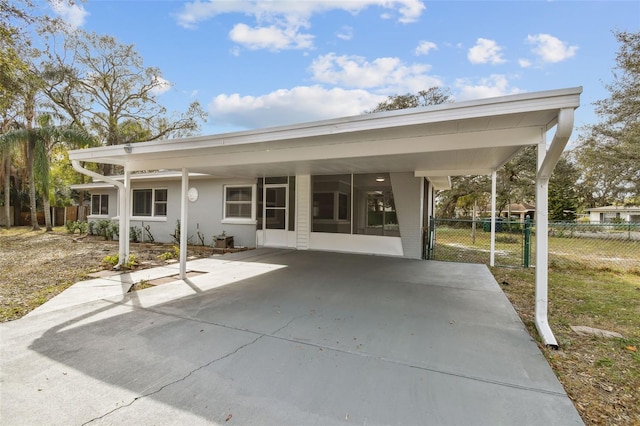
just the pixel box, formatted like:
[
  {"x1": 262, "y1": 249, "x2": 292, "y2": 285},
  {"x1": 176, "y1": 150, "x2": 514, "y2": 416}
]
[{"x1": 208, "y1": 85, "x2": 386, "y2": 129}]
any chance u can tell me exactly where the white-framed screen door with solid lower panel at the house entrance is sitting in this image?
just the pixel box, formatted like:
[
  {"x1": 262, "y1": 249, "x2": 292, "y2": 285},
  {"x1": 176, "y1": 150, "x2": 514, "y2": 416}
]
[{"x1": 262, "y1": 184, "x2": 289, "y2": 247}]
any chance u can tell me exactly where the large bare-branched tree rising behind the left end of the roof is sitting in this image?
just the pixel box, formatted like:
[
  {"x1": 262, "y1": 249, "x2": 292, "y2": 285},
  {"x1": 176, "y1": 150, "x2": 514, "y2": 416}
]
[{"x1": 44, "y1": 30, "x2": 204, "y2": 174}]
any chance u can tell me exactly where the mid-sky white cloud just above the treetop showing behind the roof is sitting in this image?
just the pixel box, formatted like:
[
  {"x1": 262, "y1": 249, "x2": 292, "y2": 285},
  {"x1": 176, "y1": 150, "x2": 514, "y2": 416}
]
[{"x1": 310, "y1": 53, "x2": 442, "y2": 94}]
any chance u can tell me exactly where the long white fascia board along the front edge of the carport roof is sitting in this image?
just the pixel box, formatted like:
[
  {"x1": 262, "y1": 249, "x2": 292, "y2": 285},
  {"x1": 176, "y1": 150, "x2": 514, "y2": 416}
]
[{"x1": 69, "y1": 87, "x2": 582, "y2": 165}]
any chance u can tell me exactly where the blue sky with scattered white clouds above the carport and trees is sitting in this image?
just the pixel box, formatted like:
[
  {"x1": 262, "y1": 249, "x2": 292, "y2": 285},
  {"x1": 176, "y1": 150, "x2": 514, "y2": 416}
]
[{"x1": 41, "y1": 0, "x2": 640, "y2": 138}]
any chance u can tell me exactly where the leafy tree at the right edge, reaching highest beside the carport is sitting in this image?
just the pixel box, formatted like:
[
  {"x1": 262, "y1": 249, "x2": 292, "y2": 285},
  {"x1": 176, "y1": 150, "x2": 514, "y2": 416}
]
[{"x1": 576, "y1": 31, "x2": 640, "y2": 207}]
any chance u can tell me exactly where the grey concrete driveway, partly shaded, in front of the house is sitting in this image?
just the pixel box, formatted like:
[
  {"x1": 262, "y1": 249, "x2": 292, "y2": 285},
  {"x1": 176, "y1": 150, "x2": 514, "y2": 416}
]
[{"x1": 0, "y1": 249, "x2": 582, "y2": 425}]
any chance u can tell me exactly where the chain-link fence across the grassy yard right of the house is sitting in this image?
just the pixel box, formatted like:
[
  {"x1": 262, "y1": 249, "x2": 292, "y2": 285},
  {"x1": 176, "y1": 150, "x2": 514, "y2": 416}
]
[{"x1": 427, "y1": 218, "x2": 640, "y2": 272}]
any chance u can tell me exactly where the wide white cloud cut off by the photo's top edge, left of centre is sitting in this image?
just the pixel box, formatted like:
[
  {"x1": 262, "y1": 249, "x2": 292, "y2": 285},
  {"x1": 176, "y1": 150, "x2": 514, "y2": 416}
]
[{"x1": 177, "y1": 0, "x2": 425, "y2": 50}]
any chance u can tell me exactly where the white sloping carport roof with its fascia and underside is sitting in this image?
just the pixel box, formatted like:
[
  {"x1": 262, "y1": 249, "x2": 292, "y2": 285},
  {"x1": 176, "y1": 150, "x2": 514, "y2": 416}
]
[{"x1": 69, "y1": 87, "x2": 582, "y2": 188}]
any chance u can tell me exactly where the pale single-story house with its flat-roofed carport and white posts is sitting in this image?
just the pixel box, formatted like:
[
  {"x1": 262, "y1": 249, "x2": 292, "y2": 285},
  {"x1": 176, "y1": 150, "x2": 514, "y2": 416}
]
[{"x1": 69, "y1": 87, "x2": 582, "y2": 346}]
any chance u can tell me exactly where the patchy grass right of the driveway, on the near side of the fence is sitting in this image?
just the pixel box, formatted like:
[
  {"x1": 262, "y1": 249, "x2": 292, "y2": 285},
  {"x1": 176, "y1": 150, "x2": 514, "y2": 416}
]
[{"x1": 492, "y1": 268, "x2": 640, "y2": 425}]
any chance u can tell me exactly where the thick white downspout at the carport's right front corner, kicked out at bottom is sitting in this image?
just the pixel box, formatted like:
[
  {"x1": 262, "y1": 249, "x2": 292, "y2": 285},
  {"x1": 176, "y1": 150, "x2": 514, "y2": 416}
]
[{"x1": 535, "y1": 108, "x2": 574, "y2": 349}]
